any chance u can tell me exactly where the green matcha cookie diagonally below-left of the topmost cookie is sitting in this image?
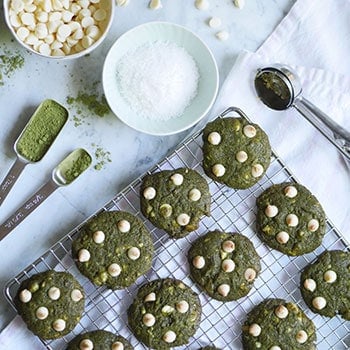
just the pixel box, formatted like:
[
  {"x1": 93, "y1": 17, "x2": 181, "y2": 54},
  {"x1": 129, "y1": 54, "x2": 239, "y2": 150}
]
[{"x1": 140, "y1": 168, "x2": 211, "y2": 238}]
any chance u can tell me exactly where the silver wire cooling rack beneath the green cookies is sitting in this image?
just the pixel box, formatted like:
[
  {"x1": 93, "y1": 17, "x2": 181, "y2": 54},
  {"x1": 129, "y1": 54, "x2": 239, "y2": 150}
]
[{"x1": 5, "y1": 108, "x2": 350, "y2": 350}]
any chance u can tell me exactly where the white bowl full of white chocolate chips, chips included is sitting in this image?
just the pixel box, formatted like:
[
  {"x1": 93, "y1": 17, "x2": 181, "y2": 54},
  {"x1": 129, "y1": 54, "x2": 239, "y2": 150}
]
[{"x1": 4, "y1": 0, "x2": 114, "y2": 58}]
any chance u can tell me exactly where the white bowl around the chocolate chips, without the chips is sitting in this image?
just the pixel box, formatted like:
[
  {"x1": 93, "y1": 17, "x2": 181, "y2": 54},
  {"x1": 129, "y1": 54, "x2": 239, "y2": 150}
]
[{"x1": 4, "y1": 0, "x2": 115, "y2": 60}]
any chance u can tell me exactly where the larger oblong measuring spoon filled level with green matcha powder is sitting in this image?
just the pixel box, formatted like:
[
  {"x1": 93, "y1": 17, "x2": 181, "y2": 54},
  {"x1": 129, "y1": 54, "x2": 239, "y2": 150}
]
[{"x1": 0, "y1": 100, "x2": 68, "y2": 205}]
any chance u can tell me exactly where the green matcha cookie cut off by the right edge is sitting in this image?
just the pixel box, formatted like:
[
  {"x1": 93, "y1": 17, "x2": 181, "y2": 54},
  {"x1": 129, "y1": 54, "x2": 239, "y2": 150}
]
[{"x1": 300, "y1": 250, "x2": 350, "y2": 320}]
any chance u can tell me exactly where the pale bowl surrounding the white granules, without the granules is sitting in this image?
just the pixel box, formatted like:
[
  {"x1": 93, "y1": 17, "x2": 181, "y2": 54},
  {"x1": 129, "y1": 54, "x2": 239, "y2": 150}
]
[{"x1": 102, "y1": 22, "x2": 219, "y2": 135}]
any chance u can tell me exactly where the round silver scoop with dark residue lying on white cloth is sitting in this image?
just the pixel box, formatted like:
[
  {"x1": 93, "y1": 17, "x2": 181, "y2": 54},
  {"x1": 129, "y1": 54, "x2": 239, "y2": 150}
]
[{"x1": 254, "y1": 64, "x2": 350, "y2": 165}]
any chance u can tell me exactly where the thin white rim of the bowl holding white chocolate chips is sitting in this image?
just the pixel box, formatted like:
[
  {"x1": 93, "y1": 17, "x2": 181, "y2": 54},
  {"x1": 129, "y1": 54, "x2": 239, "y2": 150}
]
[{"x1": 3, "y1": 0, "x2": 115, "y2": 61}]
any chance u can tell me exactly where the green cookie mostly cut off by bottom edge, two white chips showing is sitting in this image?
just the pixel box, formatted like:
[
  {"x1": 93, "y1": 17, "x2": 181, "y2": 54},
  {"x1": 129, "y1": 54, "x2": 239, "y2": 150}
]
[{"x1": 66, "y1": 330, "x2": 133, "y2": 350}]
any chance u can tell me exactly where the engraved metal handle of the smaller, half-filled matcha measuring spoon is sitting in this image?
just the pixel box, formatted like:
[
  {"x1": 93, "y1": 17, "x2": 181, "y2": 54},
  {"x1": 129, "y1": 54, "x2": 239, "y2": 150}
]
[{"x1": 0, "y1": 179, "x2": 59, "y2": 241}]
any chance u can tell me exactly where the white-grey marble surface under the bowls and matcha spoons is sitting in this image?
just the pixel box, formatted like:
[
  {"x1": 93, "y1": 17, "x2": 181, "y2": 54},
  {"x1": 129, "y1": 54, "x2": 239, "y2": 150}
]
[{"x1": 0, "y1": 0, "x2": 294, "y2": 330}]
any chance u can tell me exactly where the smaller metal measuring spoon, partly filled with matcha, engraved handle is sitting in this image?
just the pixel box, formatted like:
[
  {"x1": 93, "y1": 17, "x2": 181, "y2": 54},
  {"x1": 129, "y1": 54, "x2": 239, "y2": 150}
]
[{"x1": 0, "y1": 148, "x2": 92, "y2": 241}]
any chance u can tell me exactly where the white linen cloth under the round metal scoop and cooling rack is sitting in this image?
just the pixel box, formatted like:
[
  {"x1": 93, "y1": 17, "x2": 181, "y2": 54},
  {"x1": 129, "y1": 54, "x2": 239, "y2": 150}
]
[{"x1": 0, "y1": 0, "x2": 350, "y2": 350}]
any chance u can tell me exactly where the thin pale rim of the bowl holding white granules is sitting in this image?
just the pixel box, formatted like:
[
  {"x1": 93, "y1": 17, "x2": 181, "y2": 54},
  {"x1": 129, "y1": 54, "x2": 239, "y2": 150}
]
[{"x1": 102, "y1": 21, "x2": 219, "y2": 136}]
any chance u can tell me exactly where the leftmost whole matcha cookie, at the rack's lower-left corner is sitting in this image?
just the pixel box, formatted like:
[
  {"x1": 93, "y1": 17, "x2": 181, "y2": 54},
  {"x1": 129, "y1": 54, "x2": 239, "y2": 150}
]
[{"x1": 14, "y1": 271, "x2": 84, "y2": 339}]
